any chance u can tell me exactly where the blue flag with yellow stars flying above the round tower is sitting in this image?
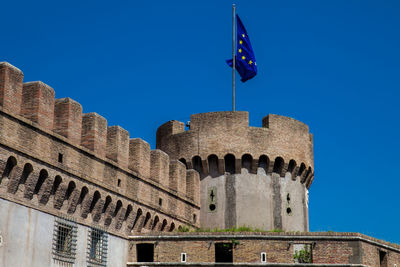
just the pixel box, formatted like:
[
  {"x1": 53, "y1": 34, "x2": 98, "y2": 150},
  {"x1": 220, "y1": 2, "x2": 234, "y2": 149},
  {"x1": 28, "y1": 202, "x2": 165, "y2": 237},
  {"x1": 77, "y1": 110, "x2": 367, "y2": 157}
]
[{"x1": 226, "y1": 15, "x2": 257, "y2": 82}]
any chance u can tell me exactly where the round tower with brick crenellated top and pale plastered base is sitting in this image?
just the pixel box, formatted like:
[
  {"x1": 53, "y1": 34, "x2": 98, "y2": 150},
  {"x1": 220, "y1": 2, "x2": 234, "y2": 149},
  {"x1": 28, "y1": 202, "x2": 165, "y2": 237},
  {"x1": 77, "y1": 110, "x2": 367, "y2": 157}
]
[{"x1": 157, "y1": 111, "x2": 314, "y2": 231}]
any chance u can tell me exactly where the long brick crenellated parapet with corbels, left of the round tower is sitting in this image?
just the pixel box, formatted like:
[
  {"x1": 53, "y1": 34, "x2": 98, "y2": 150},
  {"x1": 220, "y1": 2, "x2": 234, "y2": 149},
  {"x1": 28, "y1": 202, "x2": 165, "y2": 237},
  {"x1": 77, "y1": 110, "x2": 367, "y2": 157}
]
[{"x1": 0, "y1": 62, "x2": 200, "y2": 234}]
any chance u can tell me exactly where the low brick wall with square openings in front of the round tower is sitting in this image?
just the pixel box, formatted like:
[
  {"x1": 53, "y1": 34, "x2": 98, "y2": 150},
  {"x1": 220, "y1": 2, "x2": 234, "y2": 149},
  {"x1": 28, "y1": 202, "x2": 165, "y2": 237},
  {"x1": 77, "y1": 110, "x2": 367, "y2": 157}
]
[{"x1": 128, "y1": 233, "x2": 400, "y2": 266}]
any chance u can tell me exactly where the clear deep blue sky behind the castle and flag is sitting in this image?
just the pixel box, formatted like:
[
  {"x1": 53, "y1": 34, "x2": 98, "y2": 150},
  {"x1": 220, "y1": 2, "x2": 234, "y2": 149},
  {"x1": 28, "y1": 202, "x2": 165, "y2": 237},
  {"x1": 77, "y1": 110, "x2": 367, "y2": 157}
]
[{"x1": 0, "y1": 0, "x2": 400, "y2": 243}]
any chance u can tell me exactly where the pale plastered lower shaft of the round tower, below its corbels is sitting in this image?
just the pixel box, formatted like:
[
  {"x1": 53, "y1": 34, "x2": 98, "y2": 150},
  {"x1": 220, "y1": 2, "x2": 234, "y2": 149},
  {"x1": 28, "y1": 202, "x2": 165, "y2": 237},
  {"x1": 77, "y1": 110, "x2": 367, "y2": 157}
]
[{"x1": 200, "y1": 168, "x2": 308, "y2": 231}]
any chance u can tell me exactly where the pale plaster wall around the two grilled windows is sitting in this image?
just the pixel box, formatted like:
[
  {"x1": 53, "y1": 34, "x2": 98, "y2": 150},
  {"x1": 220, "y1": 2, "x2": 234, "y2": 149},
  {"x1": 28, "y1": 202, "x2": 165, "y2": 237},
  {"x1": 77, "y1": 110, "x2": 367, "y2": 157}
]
[{"x1": 0, "y1": 199, "x2": 128, "y2": 267}]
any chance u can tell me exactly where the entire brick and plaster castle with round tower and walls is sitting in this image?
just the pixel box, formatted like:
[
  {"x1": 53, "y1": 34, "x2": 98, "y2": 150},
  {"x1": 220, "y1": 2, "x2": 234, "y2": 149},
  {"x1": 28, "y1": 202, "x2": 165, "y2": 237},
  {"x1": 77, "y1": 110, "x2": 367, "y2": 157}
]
[{"x1": 0, "y1": 62, "x2": 400, "y2": 267}]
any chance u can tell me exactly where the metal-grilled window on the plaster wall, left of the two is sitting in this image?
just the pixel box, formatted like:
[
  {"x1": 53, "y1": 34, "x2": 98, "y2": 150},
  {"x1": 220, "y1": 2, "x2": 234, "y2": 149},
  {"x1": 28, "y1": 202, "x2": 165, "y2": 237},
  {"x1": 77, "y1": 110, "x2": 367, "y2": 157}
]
[{"x1": 53, "y1": 218, "x2": 78, "y2": 266}]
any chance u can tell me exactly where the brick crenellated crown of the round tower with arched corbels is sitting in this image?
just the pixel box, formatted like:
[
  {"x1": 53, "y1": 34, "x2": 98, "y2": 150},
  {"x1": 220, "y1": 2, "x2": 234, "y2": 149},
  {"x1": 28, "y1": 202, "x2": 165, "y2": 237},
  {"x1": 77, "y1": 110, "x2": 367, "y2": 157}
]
[{"x1": 157, "y1": 111, "x2": 314, "y2": 187}]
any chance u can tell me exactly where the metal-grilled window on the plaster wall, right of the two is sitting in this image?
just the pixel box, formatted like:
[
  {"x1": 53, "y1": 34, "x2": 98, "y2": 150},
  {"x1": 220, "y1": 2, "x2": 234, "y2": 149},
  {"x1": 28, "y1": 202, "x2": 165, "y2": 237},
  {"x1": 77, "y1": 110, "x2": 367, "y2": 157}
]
[{"x1": 88, "y1": 228, "x2": 108, "y2": 266}]
